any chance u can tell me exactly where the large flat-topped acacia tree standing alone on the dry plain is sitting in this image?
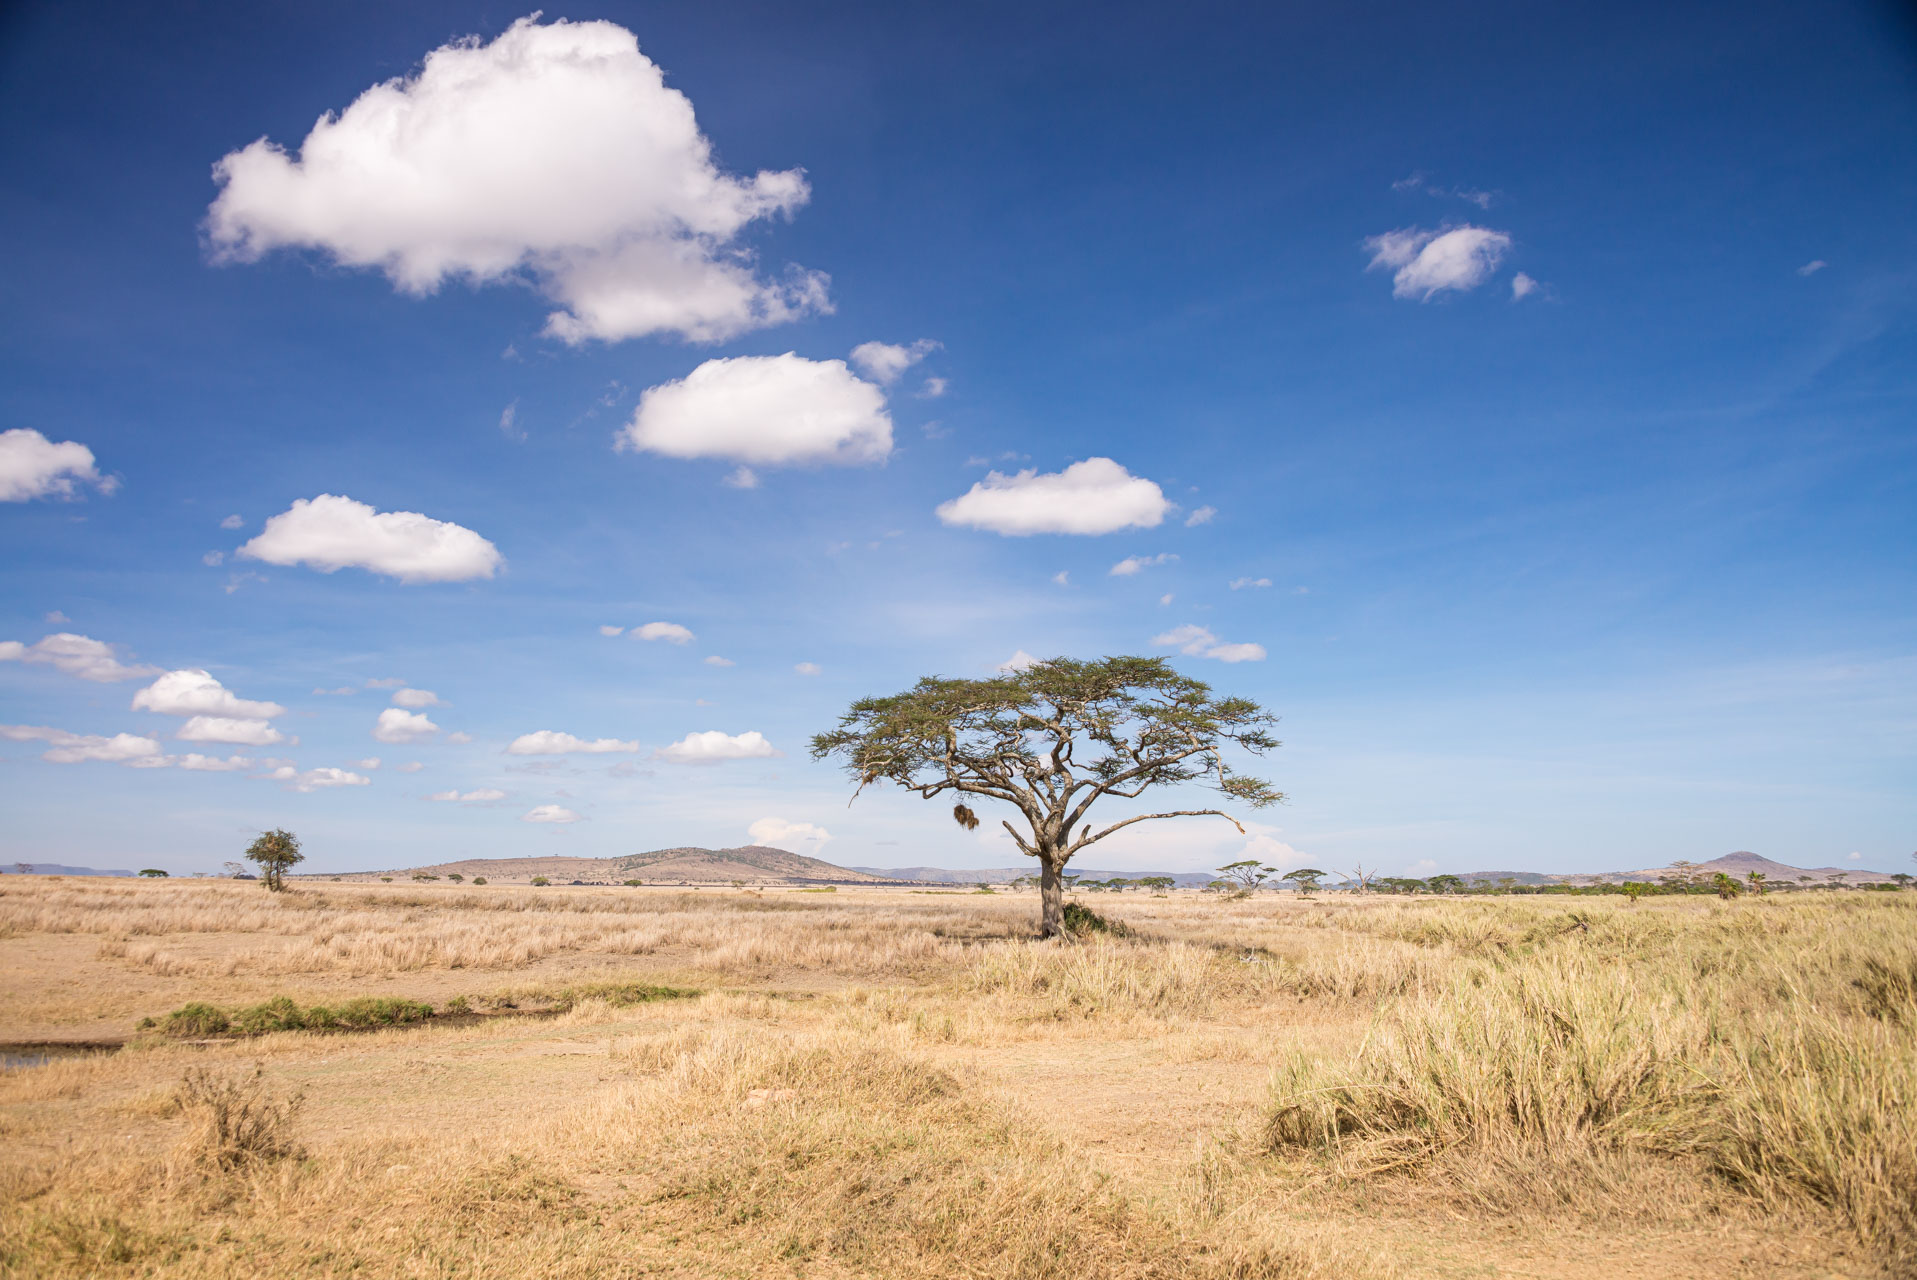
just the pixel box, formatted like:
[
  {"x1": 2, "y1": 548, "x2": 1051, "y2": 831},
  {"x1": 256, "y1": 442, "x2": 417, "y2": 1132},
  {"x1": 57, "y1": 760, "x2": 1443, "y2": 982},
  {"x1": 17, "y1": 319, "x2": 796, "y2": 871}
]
[{"x1": 813, "y1": 657, "x2": 1284, "y2": 937}]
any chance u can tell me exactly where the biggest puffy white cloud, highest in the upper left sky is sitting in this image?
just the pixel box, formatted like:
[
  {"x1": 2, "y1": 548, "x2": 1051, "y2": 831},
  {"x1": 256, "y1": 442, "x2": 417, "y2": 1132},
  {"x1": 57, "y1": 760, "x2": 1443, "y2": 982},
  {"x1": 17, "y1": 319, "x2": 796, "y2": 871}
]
[{"x1": 207, "y1": 17, "x2": 830, "y2": 343}]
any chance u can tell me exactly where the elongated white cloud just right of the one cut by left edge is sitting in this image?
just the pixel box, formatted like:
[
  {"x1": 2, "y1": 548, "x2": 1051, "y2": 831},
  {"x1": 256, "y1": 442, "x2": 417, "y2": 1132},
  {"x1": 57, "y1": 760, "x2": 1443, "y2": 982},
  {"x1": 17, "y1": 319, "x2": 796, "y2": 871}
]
[{"x1": 238, "y1": 492, "x2": 504, "y2": 583}]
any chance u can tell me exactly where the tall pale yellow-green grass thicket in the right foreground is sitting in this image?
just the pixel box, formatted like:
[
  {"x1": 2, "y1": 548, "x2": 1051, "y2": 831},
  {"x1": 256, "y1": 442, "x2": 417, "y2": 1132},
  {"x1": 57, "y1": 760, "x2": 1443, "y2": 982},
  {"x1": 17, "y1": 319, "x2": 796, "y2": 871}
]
[{"x1": 1267, "y1": 904, "x2": 1917, "y2": 1267}]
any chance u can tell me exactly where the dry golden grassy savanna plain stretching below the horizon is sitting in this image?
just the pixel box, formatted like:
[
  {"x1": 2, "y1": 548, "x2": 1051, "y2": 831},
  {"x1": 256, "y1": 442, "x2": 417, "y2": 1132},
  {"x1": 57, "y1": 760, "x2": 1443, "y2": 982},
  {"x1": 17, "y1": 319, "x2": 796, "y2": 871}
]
[{"x1": 0, "y1": 876, "x2": 1917, "y2": 1280}]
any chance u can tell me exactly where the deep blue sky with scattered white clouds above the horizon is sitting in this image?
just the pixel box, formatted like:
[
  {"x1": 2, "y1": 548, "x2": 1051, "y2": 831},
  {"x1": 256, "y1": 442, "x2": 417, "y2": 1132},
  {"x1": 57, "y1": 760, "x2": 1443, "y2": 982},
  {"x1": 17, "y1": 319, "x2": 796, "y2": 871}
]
[{"x1": 0, "y1": 4, "x2": 1917, "y2": 874}]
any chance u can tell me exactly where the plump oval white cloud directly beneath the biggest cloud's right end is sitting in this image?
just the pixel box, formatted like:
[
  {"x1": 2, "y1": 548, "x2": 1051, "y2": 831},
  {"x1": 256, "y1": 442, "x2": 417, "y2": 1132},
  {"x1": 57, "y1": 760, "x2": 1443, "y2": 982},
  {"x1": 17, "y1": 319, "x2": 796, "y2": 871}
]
[{"x1": 619, "y1": 351, "x2": 891, "y2": 466}]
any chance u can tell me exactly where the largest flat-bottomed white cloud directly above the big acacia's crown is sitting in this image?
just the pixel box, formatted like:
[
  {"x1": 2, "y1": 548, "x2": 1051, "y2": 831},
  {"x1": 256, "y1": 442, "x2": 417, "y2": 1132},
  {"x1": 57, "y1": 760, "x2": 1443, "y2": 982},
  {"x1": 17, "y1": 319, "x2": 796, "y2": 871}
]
[{"x1": 939, "y1": 458, "x2": 1171, "y2": 538}]
